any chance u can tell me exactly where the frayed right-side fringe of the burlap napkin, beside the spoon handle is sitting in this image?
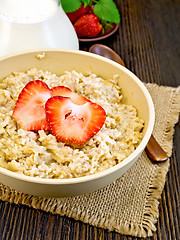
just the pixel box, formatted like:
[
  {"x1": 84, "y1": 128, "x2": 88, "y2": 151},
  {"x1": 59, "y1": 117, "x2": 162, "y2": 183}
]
[{"x1": 138, "y1": 84, "x2": 180, "y2": 237}]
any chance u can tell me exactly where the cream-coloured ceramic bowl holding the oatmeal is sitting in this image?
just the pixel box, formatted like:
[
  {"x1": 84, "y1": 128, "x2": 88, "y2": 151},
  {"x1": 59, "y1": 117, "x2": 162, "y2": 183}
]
[{"x1": 0, "y1": 49, "x2": 155, "y2": 197}]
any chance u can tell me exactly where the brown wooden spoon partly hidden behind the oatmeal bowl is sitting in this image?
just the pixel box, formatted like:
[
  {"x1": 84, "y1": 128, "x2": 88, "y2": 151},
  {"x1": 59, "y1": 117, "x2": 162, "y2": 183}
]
[{"x1": 89, "y1": 44, "x2": 168, "y2": 163}]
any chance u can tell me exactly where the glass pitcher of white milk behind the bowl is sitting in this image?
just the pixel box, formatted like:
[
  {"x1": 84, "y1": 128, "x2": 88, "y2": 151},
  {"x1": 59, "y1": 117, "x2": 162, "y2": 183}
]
[{"x1": 0, "y1": 0, "x2": 79, "y2": 57}]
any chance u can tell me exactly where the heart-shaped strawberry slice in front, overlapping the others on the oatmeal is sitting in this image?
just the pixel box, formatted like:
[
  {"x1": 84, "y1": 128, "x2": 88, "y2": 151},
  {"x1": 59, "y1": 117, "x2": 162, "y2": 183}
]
[{"x1": 45, "y1": 96, "x2": 106, "y2": 146}]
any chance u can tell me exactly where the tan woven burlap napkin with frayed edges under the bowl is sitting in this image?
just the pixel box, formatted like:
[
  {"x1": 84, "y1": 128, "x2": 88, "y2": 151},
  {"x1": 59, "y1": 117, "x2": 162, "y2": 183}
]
[{"x1": 0, "y1": 84, "x2": 180, "y2": 237}]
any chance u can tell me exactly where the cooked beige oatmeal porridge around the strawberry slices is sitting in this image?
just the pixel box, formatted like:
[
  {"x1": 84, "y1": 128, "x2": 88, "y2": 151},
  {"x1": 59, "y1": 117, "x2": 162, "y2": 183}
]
[{"x1": 0, "y1": 69, "x2": 144, "y2": 179}]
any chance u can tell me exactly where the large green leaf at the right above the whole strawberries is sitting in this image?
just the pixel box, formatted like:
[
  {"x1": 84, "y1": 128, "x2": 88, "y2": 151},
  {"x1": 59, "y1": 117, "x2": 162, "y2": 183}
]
[{"x1": 94, "y1": 0, "x2": 120, "y2": 23}]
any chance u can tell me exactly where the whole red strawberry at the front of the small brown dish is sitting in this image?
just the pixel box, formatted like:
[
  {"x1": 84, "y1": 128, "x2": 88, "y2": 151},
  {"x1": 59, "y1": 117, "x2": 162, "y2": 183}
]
[{"x1": 74, "y1": 14, "x2": 102, "y2": 38}]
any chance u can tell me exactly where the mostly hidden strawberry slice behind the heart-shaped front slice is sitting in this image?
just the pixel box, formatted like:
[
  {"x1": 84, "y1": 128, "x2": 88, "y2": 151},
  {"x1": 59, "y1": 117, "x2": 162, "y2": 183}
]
[{"x1": 51, "y1": 86, "x2": 90, "y2": 105}]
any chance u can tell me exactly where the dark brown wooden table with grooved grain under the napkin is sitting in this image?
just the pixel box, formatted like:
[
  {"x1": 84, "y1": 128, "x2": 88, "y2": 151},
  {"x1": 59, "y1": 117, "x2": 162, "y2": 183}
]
[{"x1": 0, "y1": 0, "x2": 180, "y2": 240}]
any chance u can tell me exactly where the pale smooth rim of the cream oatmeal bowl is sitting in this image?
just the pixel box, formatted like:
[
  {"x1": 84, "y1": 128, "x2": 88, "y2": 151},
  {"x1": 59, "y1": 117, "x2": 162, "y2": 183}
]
[{"x1": 0, "y1": 48, "x2": 155, "y2": 185}]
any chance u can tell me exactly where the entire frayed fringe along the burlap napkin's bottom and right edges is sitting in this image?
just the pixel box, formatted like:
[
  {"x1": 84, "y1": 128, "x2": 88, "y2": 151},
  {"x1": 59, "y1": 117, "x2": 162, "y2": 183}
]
[{"x1": 0, "y1": 84, "x2": 180, "y2": 237}]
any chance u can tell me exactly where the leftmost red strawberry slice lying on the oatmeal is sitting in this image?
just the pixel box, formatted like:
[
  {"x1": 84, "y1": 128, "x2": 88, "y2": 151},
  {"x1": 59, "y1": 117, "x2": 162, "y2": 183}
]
[{"x1": 13, "y1": 80, "x2": 51, "y2": 131}]
